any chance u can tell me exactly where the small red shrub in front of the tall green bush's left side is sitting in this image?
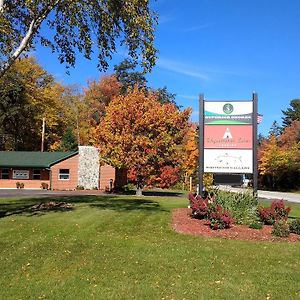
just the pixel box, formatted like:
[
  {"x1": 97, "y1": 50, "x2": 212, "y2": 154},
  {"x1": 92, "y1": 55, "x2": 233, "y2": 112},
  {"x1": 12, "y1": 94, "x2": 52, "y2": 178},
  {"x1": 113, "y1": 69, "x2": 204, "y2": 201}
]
[{"x1": 209, "y1": 203, "x2": 233, "y2": 230}]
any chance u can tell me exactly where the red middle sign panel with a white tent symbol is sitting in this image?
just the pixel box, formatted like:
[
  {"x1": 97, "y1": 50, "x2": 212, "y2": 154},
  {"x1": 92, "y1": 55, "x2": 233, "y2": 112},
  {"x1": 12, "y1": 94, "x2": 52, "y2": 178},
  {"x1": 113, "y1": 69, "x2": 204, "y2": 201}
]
[{"x1": 204, "y1": 125, "x2": 253, "y2": 149}]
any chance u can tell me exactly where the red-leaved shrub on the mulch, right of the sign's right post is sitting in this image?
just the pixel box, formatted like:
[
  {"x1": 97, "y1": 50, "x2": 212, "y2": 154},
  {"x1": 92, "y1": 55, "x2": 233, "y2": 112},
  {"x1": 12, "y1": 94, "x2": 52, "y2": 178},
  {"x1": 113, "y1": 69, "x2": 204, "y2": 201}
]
[{"x1": 257, "y1": 200, "x2": 291, "y2": 225}]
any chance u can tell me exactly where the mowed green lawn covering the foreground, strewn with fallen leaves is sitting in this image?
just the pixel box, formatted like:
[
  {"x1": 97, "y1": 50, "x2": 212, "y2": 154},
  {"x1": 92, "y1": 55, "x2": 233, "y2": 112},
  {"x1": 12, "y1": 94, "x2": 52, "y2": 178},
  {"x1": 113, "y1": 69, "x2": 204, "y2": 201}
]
[{"x1": 0, "y1": 196, "x2": 300, "y2": 299}]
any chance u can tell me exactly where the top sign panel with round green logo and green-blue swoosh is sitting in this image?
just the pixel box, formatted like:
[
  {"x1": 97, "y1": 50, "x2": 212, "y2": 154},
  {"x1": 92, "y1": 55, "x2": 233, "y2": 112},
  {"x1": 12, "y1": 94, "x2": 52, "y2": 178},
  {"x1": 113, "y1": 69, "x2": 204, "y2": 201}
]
[{"x1": 204, "y1": 101, "x2": 253, "y2": 125}]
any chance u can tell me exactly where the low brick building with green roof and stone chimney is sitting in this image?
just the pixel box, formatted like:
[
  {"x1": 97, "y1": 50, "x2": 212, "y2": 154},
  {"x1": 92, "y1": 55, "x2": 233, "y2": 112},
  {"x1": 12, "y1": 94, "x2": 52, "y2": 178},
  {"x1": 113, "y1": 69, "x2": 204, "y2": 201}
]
[{"x1": 0, "y1": 146, "x2": 127, "y2": 190}]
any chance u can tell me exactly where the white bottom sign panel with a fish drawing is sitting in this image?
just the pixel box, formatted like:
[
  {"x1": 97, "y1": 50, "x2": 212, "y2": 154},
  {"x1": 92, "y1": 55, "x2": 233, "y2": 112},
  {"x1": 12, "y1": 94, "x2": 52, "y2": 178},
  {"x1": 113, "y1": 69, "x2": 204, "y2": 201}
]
[{"x1": 204, "y1": 149, "x2": 253, "y2": 174}]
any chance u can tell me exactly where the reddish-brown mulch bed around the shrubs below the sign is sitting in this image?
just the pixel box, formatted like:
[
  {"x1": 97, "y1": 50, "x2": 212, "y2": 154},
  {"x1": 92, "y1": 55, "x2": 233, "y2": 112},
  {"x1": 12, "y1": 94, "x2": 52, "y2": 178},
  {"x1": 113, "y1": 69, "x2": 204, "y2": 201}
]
[{"x1": 172, "y1": 208, "x2": 300, "y2": 242}]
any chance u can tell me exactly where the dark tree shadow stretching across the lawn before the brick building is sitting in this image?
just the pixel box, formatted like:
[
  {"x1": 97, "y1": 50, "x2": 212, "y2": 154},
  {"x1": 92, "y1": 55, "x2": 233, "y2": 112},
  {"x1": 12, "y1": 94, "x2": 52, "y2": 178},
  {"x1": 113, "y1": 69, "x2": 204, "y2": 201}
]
[{"x1": 0, "y1": 195, "x2": 164, "y2": 218}]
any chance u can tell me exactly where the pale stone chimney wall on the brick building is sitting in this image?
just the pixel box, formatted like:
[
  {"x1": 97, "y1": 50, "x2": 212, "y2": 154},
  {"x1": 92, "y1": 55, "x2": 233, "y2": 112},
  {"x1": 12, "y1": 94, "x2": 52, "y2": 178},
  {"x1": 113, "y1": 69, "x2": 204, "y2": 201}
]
[{"x1": 78, "y1": 146, "x2": 100, "y2": 189}]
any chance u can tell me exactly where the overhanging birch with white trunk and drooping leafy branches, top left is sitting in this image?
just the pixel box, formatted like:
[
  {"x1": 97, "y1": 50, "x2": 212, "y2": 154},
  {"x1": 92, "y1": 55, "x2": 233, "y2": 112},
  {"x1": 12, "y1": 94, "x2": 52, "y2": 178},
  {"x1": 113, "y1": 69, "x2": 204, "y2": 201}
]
[{"x1": 0, "y1": 0, "x2": 156, "y2": 77}]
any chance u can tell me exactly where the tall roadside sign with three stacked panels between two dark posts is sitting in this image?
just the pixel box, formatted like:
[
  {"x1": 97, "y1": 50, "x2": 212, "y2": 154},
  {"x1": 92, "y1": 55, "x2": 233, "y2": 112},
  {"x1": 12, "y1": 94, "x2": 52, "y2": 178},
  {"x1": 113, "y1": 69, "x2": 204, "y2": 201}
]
[{"x1": 199, "y1": 93, "x2": 257, "y2": 196}]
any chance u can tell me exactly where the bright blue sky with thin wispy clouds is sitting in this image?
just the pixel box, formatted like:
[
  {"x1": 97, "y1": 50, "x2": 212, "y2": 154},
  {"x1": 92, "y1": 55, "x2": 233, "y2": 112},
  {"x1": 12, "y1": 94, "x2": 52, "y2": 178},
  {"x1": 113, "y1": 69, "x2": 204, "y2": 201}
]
[{"x1": 35, "y1": 0, "x2": 300, "y2": 135}]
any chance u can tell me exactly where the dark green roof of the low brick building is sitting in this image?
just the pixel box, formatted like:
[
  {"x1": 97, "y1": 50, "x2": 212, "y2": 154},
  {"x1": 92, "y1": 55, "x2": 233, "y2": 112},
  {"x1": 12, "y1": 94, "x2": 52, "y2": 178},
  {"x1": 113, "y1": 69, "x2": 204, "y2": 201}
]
[{"x1": 0, "y1": 151, "x2": 78, "y2": 168}]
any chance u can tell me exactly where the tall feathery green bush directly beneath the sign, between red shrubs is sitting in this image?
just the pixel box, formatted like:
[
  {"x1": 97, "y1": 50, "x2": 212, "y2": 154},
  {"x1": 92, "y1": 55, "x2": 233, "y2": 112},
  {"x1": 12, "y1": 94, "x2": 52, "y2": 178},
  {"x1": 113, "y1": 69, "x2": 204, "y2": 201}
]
[{"x1": 214, "y1": 190, "x2": 258, "y2": 224}]
